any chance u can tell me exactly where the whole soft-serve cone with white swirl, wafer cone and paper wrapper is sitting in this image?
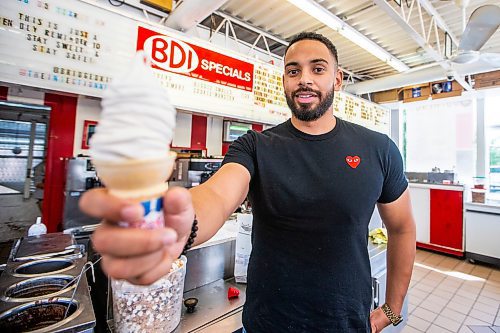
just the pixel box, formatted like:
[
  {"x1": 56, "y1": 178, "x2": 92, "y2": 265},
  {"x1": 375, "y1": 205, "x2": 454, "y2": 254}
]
[{"x1": 90, "y1": 51, "x2": 176, "y2": 223}]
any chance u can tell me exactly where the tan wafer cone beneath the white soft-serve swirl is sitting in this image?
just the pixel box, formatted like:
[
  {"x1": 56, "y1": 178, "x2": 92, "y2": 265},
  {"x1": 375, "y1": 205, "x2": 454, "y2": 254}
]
[{"x1": 93, "y1": 152, "x2": 176, "y2": 202}]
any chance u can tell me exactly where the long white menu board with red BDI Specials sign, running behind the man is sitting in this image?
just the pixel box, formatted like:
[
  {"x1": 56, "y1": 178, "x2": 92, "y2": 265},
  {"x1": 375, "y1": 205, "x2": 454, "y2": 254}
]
[{"x1": 0, "y1": 0, "x2": 389, "y2": 133}]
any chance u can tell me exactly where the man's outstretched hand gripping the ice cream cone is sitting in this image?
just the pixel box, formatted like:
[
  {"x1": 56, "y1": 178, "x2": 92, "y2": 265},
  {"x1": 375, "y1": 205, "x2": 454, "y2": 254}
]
[{"x1": 80, "y1": 187, "x2": 194, "y2": 285}]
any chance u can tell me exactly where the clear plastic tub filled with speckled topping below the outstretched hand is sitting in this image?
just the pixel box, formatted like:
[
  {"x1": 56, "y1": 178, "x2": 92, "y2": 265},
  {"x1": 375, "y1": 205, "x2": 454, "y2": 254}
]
[{"x1": 111, "y1": 256, "x2": 187, "y2": 333}]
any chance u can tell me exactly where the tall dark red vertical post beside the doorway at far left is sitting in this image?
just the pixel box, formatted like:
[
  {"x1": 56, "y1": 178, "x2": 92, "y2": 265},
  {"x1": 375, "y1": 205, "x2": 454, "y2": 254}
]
[{"x1": 42, "y1": 93, "x2": 77, "y2": 232}]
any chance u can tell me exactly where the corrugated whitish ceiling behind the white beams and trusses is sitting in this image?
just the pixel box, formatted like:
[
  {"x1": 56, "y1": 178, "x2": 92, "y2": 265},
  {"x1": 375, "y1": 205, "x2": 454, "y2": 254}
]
[{"x1": 211, "y1": 0, "x2": 500, "y2": 83}]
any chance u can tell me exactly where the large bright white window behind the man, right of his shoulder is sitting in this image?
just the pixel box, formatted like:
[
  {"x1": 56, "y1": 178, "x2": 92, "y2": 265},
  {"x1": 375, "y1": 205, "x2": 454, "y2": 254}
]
[{"x1": 402, "y1": 97, "x2": 476, "y2": 184}]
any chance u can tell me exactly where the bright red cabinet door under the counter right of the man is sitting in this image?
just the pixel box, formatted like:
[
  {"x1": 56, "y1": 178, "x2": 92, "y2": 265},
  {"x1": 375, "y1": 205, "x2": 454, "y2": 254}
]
[{"x1": 430, "y1": 189, "x2": 463, "y2": 250}]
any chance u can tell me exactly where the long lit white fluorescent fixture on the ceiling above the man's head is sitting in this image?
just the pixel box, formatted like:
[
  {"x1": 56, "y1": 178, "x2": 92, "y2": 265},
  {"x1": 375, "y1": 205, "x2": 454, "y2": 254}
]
[{"x1": 288, "y1": 0, "x2": 410, "y2": 72}]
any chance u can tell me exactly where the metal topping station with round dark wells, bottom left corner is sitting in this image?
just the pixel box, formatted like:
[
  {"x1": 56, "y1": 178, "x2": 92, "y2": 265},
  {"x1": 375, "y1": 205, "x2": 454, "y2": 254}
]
[{"x1": 0, "y1": 233, "x2": 96, "y2": 333}]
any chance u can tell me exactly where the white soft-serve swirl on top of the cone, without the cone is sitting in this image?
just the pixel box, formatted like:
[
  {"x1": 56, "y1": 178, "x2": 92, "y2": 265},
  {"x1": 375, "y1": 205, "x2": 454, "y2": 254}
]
[{"x1": 90, "y1": 52, "x2": 175, "y2": 162}]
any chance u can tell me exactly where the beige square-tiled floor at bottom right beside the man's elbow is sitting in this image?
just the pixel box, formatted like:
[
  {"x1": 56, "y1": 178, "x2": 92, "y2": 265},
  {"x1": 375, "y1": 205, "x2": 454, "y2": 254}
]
[{"x1": 403, "y1": 250, "x2": 500, "y2": 333}]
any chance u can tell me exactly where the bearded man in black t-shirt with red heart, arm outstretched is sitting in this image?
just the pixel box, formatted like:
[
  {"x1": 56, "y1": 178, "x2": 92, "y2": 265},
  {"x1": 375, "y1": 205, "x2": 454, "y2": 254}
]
[{"x1": 81, "y1": 33, "x2": 415, "y2": 333}]
